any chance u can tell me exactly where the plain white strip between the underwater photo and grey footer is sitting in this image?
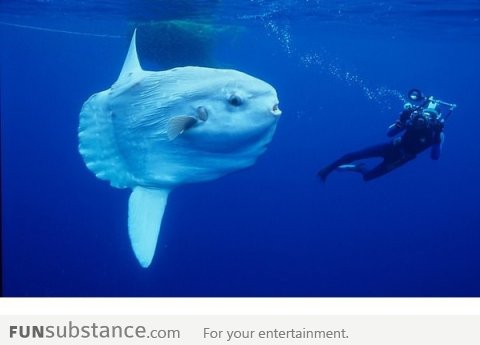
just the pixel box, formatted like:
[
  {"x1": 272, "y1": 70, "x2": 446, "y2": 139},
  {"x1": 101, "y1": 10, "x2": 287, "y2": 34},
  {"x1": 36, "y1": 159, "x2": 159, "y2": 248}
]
[{"x1": 0, "y1": 298, "x2": 480, "y2": 315}]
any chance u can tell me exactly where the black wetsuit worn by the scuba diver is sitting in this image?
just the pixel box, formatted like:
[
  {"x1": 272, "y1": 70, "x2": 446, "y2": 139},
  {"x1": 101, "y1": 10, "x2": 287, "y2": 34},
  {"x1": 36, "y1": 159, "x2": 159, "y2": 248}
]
[{"x1": 318, "y1": 110, "x2": 443, "y2": 181}]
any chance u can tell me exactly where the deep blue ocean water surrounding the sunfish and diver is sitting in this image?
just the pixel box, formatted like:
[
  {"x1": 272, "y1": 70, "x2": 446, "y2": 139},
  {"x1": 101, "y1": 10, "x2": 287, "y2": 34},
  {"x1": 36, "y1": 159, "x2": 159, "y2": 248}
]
[{"x1": 0, "y1": 0, "x2": 480, "y2": 297}]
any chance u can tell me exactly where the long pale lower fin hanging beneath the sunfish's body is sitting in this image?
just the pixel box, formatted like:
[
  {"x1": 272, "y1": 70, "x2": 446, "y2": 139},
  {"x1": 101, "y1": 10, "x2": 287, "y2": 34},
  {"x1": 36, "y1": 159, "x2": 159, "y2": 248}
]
[{"x1": 128, "y1": 186, "x2": 170, "y2": 268}]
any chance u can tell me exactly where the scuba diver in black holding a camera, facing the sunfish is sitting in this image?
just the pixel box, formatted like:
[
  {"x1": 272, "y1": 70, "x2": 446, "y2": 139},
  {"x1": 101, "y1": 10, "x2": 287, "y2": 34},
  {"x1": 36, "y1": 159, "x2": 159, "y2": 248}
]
[{"x1": 318, "y1": 89, "x2": 456, "y2": 182}]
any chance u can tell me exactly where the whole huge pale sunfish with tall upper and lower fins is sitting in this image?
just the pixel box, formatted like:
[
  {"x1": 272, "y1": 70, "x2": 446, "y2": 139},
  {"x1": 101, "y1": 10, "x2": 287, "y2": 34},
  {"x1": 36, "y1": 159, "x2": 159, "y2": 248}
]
[{"x1": 78, "y1": 30, "x2": 281, "y2": 267}]
